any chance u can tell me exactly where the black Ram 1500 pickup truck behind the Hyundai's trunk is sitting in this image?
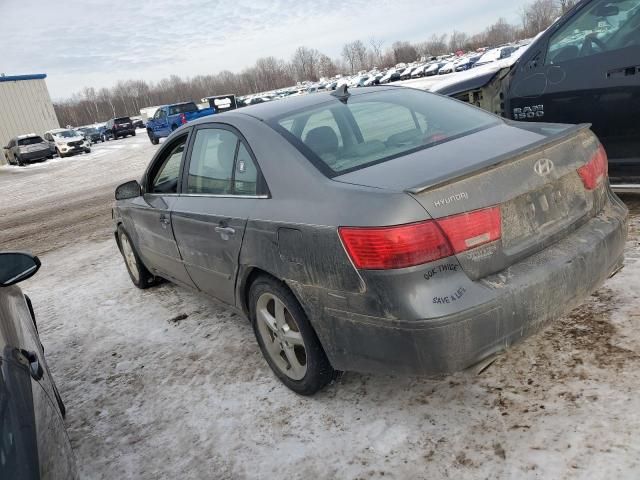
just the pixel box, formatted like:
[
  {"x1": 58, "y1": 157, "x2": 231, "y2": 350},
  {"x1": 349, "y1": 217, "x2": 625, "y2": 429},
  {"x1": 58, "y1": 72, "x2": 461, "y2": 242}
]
[{"x1": 431, "y1": 0, "x2": 640, "y2": 192}]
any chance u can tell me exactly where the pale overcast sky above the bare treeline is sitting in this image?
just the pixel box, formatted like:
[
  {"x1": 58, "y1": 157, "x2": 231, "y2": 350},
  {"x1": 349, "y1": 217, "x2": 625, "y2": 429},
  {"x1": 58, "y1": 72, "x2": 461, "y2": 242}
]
[{"x1": 0, "y1": 0, "x2": 530, "y2": 99}]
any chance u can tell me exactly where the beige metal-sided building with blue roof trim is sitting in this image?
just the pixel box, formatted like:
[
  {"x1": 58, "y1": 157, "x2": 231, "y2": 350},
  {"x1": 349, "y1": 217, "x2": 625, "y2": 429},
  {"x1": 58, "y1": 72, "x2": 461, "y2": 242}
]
[{"x1": 0, "y1": 73, "x2": 60, "y2": 164}]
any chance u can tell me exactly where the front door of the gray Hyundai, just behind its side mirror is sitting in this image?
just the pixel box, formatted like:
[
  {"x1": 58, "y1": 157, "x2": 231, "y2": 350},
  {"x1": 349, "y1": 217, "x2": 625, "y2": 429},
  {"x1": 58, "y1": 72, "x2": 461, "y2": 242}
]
[{"x1": 121, "y1": 133, "x2": 194, "y2": 287}]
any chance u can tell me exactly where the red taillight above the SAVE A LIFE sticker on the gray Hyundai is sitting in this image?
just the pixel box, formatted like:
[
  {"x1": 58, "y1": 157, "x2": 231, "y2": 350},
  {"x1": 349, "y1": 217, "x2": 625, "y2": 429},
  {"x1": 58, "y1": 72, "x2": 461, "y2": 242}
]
[{"x1": 338, "y1": 207, "x2": 501, "y2": 270}]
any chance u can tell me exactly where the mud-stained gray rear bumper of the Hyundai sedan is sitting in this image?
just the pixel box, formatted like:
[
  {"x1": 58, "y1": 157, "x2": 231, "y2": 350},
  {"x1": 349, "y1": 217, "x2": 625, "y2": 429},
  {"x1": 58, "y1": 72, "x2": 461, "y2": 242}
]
[{"x1": 316, "y1": 196, "x2": 627, "y2": 375}]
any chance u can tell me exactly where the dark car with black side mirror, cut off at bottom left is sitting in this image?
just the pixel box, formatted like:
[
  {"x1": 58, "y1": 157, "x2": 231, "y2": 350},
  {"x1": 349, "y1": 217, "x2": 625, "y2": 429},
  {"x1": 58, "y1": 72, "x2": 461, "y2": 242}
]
[{"x1": 0, "y1": 252, "x2": 77, "y2": 480}]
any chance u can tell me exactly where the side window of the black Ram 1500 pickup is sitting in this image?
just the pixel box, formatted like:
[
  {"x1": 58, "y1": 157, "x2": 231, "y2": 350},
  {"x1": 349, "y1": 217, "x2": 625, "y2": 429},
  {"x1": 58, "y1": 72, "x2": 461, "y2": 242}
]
[{"x1": 545, "y1": 0, "x2": 640, "y2": 65}]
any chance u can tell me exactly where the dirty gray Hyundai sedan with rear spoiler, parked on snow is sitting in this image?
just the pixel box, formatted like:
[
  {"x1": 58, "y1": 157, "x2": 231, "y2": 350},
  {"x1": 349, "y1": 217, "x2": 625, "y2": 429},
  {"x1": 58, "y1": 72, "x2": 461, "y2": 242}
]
[{"x1": 113, "y1": 87, "x2": 627, "y2": 395}]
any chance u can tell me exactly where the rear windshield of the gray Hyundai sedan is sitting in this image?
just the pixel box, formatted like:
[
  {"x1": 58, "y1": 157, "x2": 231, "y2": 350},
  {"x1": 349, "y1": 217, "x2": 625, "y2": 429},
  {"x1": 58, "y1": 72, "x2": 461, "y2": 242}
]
[{"x1": 269, "y1": 89, "x2": 500, "y2": 176}]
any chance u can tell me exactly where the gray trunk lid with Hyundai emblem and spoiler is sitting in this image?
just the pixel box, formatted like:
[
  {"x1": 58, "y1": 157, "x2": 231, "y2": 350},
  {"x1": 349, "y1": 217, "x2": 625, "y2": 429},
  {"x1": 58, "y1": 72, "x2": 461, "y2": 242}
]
[{"x1": 332, "y1": 125, "x2": 604, "y2": 279}]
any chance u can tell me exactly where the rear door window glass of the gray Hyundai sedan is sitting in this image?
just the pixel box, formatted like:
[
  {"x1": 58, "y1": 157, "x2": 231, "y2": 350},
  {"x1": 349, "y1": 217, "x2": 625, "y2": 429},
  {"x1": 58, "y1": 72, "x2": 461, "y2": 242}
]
[{"x1": 187, "y1": 128, "x2": 258, "y2": 195}]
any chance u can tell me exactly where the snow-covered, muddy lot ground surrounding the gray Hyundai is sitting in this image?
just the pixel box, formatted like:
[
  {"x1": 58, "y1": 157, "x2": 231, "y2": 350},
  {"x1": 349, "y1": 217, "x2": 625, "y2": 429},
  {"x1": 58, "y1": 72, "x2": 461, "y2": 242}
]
[{"x1": 0, "y1": 134, "x2": 640, "y2": 479}]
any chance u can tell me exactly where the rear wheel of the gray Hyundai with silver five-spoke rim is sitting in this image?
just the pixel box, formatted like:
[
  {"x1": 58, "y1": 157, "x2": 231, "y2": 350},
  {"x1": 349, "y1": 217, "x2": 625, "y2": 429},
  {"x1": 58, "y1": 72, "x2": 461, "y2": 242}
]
[{"x1": 249, "y1": 276, "x2": 338, "y2": 395}]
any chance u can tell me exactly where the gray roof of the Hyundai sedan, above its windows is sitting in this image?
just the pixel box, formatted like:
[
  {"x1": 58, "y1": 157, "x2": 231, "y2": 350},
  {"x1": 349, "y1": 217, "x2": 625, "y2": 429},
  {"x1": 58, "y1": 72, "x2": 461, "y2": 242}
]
[{"x1": 189, "y1": 85, "x2": 403, "y2": 125}]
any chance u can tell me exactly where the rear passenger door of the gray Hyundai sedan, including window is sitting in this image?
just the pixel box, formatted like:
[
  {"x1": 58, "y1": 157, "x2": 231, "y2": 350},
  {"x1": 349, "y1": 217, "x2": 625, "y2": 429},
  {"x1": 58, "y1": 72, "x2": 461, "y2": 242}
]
[{"x1": 171, "y1": 125, "x2": 266, "y2": 304}]
